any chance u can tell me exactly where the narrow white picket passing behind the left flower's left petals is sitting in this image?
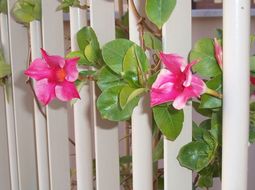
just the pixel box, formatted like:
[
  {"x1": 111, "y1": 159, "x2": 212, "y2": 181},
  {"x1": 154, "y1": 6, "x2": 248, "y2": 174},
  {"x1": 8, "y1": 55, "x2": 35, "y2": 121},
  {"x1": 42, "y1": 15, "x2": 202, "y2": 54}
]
[{"x1": 30, "y1": 21, "x2": 50, "y2": 190}]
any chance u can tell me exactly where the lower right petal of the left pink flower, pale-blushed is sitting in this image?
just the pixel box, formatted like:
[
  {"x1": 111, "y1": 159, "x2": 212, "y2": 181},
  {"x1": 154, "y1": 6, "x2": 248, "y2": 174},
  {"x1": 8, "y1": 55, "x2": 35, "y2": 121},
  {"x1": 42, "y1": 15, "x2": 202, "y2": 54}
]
[{"x1": 55, "y1": 81, "x2": 80, "y2": 101}]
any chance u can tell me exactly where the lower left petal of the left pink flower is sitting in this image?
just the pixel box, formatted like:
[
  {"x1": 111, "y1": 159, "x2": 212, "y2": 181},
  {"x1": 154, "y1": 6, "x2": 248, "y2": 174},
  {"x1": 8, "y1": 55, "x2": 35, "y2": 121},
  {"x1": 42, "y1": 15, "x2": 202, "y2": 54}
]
[{"x1": 35, "y1": 79, "x2": 56, "y2": 105}]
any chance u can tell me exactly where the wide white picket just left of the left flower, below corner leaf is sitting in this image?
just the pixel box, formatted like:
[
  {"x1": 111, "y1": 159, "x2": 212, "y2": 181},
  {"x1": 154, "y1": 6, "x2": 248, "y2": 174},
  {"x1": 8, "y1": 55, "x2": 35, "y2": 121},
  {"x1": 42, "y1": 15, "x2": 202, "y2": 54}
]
[{"x1": 8, "y1": 0, "x2": 38, "y2": 190}]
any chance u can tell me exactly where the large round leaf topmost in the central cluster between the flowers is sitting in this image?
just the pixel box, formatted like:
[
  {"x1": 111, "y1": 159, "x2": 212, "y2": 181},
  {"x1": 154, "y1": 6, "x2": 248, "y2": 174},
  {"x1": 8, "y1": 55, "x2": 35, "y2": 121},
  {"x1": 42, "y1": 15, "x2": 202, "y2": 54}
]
[{"x1": 102, "y1": 39, "x2": 149, "y2": 75}]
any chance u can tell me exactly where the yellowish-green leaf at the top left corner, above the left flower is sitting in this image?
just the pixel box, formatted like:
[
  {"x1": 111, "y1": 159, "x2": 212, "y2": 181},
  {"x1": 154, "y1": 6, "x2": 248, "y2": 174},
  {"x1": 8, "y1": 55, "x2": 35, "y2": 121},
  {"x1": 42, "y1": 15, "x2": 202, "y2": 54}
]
[{"x1": 12, "y1": 0, "x2": 41, "y2": 25}]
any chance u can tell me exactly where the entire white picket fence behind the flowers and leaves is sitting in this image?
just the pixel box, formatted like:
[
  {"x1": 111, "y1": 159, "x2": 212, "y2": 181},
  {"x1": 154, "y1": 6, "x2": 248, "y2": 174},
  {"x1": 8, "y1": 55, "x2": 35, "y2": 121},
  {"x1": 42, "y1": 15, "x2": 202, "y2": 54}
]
[{"x1": 0, "y1": 0, "x2": 250, "y2": 190}]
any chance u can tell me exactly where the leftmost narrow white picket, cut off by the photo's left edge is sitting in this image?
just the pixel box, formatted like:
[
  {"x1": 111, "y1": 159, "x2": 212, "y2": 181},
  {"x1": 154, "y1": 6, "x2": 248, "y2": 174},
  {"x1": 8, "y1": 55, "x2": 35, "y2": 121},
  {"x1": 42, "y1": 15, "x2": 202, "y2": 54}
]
[{"x1": 0, "y1": 13, "x2": 13, "y2": 190}]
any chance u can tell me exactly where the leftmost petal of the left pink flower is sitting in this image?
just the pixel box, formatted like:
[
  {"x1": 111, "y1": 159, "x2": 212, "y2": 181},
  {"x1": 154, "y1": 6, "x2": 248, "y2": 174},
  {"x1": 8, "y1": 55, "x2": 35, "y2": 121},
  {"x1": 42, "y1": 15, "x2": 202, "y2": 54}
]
[{"x1": 24, "y1": 59, "x2": 53, "y2": 80}]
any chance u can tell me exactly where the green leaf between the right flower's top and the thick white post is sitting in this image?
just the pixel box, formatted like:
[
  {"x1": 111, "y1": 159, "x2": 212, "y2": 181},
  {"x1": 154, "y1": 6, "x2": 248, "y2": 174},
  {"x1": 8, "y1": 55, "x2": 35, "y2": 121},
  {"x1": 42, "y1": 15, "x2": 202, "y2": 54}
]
[{"x1": 189, "y1": 38, "x2": 221, "y2": 77}]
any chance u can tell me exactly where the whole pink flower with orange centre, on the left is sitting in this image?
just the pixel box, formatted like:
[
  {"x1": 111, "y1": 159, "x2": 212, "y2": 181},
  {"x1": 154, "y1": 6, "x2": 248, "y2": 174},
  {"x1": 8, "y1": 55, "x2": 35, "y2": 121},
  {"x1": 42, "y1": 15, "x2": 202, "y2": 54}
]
[{"x1": 24, "y1": 49, "x2": 80, "y2": 105}]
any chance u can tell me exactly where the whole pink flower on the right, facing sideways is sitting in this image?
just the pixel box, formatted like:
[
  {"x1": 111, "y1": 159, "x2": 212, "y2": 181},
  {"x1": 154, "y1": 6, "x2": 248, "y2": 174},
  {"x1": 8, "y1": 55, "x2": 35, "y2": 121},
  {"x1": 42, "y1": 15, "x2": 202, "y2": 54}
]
[{"x1": 151, "y1": 53, "x2": 207, "y2": 110}]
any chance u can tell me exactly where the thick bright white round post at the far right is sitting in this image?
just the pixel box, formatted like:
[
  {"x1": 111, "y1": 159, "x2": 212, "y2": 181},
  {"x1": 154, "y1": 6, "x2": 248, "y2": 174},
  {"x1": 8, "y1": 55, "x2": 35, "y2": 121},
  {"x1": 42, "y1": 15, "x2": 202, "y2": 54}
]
[{"x1": 222, "y1": 0, "x2": 250, "y2": 190}]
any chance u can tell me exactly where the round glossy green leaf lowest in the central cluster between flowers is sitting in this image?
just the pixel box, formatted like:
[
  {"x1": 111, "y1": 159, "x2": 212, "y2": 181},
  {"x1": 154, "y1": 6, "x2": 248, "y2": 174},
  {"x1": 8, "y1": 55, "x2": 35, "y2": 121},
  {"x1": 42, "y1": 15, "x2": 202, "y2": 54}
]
[{"x1": 97, "y1": 85, "x2": 139, "y2": 121}]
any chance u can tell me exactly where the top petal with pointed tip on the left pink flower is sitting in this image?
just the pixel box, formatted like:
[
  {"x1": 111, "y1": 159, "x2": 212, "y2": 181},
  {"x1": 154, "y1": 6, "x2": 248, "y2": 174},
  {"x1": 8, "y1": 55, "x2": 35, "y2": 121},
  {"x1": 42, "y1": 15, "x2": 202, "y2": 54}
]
[{"x1": 41, "y1": 49, "x2": 65, "y2": 68}]
